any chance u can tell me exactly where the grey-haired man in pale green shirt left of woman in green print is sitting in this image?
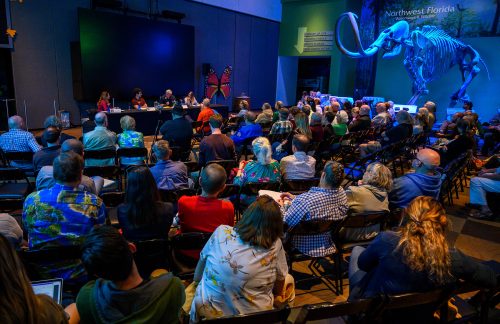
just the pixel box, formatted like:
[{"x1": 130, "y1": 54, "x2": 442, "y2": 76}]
[{"x1": 83, "y1": 112, "x2": 116, "y2": 166}]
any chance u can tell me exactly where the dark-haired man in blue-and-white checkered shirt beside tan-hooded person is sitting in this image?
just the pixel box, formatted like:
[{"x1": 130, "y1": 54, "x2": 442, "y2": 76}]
[{"x1": 281, "y1": 162, "x2": 349, "y2": 257}]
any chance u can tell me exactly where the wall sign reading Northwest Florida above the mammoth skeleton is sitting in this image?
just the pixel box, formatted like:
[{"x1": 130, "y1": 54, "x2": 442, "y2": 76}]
[{"x1": 379, "y1": 0, "x2": 500, "y2": 38}]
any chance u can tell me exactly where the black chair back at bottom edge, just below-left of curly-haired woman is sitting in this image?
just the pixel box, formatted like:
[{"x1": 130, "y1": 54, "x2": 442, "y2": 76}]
[{"x1": 294, "y1": 298, "x2": 381, "y2": 324}]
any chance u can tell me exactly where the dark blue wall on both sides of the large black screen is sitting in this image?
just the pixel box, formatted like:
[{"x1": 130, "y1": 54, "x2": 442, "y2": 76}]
[{"x1": 11, "y1": 0, "x2": 279, "y2": 128}]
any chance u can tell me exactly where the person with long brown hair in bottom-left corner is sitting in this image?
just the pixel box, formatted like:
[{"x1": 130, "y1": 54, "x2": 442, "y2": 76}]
[{"x1": 0, "y1": 234, "x2": 68, "y2": 324}]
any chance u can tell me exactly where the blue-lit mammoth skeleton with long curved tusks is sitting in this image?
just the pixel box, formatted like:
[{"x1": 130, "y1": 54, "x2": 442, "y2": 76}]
[{"x1": 335, "y1": 12, "x2": 489, "y2": 106}]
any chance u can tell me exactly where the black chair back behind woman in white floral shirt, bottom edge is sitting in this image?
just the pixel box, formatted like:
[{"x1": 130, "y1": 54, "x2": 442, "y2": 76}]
[{"x1": 201, "y1": 307, "x2": 290, "y2": 324}]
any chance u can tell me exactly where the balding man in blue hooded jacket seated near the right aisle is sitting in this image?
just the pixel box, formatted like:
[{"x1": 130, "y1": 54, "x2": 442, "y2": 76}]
[{"x1": 389, "y1": 149, "x2": 441, "y2": 208}]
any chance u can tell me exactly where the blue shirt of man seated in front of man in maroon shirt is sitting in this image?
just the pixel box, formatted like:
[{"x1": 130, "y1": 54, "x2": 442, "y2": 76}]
[{"x1": 151, "y1": 160, "x2": 189, "y2": 190}]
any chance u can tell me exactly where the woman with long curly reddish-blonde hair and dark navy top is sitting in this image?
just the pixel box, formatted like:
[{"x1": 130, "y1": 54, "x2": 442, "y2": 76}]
[{"x1": 349, "y1": 197, "x2": 497, "y2": 312}]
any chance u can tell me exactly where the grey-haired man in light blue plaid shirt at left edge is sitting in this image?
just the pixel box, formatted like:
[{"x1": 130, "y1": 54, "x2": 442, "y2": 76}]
[{"x1": 0, "y1": 115, "x2": 42, "y2": 170}]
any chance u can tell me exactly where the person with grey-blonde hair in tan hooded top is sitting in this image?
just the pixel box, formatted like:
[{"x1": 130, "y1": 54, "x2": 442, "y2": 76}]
[{"x1": 346, "y1": 162, "x2": 392, "y2": 241}]
